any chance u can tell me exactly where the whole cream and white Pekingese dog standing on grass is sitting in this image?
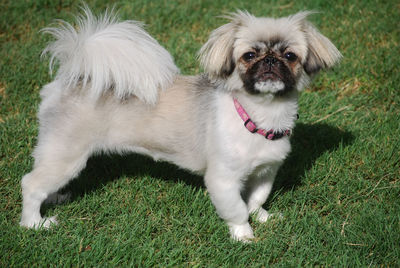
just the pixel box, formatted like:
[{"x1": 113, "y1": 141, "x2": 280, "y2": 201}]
[{"x1": 20, "y1": 7, "x2": 341, "y2": 241}]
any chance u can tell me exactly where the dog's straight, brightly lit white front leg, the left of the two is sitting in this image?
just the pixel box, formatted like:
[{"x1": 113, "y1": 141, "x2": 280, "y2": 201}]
[{"x1": 205, "y1": 165, "x2": 254, "y2": 242}]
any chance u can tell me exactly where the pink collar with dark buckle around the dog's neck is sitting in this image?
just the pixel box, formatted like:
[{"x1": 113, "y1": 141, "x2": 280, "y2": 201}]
[{"x1": 233, "y1": 98, "x2": 291, "y2": 140}]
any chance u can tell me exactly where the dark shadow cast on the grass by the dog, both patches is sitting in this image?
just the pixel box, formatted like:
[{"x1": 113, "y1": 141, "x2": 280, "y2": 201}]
[{"x1": 57, "y1": 123, "x2": 353, "y2": 203}]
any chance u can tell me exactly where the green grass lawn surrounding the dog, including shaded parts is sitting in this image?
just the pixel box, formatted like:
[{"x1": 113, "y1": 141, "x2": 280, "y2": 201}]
[{"x1": 0, "y1": 0, "x2": 400, "y2": 267}]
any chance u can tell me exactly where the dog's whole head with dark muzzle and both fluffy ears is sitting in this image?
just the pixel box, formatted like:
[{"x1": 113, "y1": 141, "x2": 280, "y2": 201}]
[{"x1": 200, "y1": 12, "x2": 341, "y2": 96}]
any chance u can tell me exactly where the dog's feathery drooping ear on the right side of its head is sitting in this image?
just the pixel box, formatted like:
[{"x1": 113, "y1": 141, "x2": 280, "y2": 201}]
[{"x1": 294, "y1": 12, "x2": 342, "y2": 75}]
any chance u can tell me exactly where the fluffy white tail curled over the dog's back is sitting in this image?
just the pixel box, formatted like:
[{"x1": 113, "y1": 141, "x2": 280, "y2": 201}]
[{"x1": 43, "y1": 6, "x2": 179, "y2": 104}]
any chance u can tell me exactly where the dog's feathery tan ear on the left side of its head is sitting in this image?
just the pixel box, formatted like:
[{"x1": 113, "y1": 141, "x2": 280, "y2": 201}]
[{"x1": 199, "y1": 11, "x2": 252, "y2": 79}]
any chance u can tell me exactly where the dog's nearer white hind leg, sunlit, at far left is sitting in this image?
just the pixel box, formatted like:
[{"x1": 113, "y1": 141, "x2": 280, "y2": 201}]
[{"x1": 20, "y1": 136, "x2": 91, "y2": 228}]
